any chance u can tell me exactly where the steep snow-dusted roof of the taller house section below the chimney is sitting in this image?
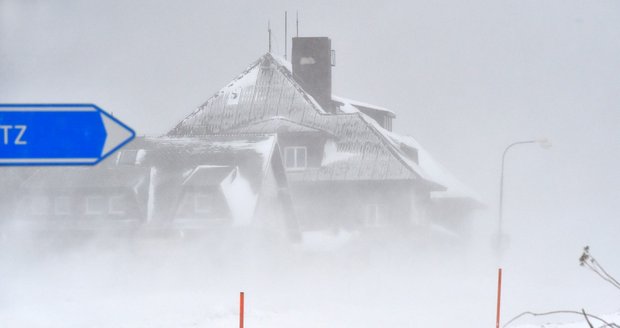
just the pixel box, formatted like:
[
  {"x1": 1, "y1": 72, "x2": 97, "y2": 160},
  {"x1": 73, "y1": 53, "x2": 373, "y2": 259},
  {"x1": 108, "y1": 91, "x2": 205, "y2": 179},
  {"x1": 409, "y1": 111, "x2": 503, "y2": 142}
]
[{"x1": 168, "y1": 53, "x2": 479, "y2": 200}]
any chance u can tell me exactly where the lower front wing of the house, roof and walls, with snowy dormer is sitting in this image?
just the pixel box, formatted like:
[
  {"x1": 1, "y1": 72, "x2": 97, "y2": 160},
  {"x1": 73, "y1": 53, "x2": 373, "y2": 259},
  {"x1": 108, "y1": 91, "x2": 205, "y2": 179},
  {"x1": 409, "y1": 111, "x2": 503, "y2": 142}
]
[{"x1": 127, "y1": 134, "x2": 298, "y2": 237}]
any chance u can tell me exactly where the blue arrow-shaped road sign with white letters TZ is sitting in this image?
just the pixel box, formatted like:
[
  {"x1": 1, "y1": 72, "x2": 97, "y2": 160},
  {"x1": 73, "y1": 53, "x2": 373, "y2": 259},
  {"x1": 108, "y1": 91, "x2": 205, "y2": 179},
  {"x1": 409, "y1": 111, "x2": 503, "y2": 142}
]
[{"x1": 0, "y1": 104, "x2": 135, "y2": 165}]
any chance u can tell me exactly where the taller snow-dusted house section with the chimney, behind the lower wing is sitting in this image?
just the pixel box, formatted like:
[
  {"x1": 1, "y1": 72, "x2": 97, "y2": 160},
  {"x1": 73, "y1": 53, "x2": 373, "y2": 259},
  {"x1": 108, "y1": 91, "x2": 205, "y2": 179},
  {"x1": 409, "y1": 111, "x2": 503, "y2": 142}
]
[{"x1": 167, "y1": 37, "x2": 480, "y2": 230}]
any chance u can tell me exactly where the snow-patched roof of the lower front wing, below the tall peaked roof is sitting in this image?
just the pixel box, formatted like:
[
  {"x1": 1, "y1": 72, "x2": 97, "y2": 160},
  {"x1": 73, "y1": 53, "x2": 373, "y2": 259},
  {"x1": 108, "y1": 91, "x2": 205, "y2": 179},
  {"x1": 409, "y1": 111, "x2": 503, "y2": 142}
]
[{"x1": 127, "y1": 134, "x2": 278, "y2": 224}]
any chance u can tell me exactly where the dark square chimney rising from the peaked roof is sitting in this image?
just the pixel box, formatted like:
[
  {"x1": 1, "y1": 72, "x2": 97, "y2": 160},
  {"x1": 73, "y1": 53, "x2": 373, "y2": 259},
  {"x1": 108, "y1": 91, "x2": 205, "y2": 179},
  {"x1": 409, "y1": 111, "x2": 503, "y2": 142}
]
[{"x1": 291, "y1": 37, "x2": 335, "y2": 113}]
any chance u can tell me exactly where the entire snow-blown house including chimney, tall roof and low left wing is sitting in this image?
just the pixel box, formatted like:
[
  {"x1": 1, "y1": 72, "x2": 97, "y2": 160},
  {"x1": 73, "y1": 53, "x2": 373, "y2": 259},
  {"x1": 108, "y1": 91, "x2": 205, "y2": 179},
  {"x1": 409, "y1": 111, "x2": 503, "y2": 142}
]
[{"x1": 1, "y1": 37, "x2": 480, "y2": 237}]
